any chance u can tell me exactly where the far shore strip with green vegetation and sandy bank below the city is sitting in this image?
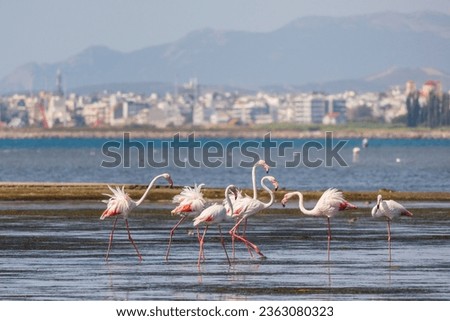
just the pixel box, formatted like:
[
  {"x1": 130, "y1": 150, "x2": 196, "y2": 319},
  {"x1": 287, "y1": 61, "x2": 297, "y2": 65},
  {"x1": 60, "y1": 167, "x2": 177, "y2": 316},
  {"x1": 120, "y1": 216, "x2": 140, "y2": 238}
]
[{"x1": 0, "y1": 122, "x2": 450, "y2": 139}]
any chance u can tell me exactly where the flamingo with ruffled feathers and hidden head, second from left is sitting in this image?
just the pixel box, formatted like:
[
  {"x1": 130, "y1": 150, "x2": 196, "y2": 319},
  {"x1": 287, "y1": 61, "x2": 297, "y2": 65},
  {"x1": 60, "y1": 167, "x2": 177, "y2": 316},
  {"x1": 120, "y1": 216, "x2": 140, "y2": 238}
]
[{"x1": 165, "y1": 184, "x2": 206, "y2": 261}]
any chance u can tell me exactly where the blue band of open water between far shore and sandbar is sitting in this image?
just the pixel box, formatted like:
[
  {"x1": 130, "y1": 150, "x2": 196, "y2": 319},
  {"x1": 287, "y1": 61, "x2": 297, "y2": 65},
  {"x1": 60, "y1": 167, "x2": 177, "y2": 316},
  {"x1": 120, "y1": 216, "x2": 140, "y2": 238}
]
[{"x1": 0, "y1": 138, "x2": 450, "y2": 191}]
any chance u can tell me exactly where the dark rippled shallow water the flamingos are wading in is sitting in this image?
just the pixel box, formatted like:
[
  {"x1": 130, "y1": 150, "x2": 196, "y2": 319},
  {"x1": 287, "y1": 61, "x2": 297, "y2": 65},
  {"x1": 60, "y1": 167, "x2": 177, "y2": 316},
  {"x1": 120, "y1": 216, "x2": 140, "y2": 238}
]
[{"x1": 0, "y1": 203, "x2": 450, "y2": 300}]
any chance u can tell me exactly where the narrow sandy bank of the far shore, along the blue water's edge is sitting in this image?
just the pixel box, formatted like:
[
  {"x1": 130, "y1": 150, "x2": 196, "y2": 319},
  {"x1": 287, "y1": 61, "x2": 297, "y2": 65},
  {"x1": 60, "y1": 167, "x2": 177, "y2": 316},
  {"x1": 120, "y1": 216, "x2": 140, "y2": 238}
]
[{"x1": 0, "y1": 127, "x2": 450, "y2": 139}]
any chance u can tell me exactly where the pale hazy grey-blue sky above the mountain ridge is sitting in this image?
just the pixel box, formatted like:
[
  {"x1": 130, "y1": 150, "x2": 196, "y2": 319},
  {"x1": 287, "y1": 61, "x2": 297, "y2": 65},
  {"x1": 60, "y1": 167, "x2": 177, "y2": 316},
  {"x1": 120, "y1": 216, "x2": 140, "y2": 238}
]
[{"x1": 0, "y1": 0, "x2": 450, "y2": 78}]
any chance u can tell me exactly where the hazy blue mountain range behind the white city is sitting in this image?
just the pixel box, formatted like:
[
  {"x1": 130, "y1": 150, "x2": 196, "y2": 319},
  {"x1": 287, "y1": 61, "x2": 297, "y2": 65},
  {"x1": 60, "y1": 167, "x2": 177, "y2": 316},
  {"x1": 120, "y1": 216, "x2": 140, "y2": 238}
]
[{"x1": 0, "y1": 12, "x2": 450, "y2": 93}]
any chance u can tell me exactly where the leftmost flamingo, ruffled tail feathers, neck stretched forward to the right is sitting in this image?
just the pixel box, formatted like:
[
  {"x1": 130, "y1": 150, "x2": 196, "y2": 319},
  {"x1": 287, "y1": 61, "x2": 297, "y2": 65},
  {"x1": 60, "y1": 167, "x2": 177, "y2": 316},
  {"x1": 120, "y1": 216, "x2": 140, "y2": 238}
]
[{"x1": 100, "y1": 173, "x2": 173, "y2": 261}]
